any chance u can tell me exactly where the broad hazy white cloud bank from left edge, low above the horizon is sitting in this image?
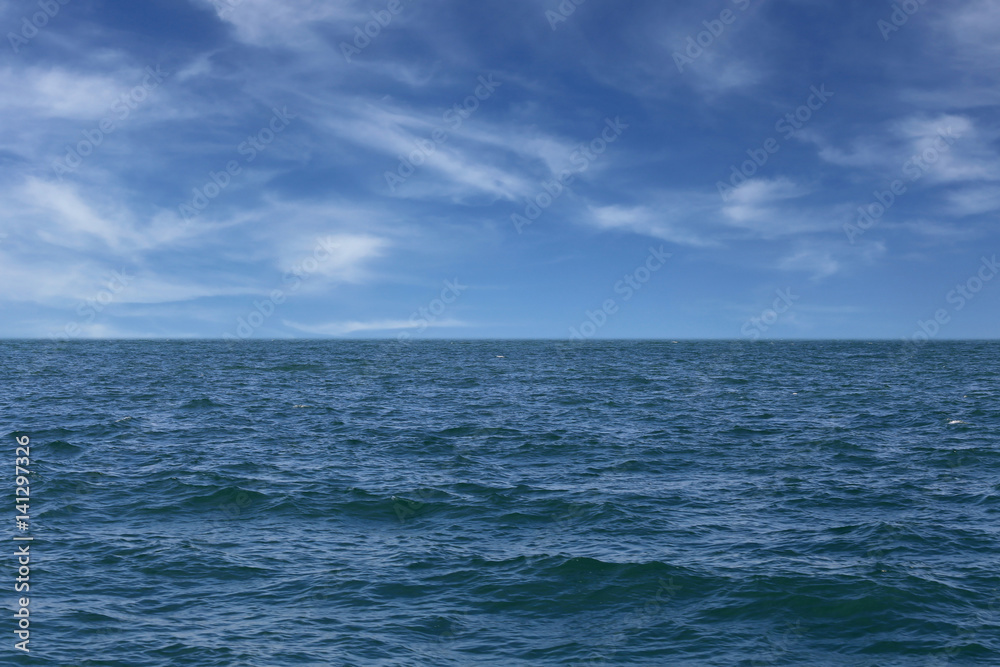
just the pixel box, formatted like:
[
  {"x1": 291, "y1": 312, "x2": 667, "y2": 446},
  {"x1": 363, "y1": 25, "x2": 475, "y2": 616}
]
[{"x1": 0, "y1": 178, "x2": 391, "y2": 306}]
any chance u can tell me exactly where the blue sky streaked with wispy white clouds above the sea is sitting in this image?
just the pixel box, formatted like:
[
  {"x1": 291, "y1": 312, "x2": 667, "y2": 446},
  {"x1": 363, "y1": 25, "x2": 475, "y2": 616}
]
[{"x1": 0, "y1": 0, "x2": 1000, "y2": 339}]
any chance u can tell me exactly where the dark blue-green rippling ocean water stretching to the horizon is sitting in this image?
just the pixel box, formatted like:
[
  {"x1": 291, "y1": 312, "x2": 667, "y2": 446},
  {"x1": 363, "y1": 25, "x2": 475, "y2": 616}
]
[{"x1": 0, "y1": 341, "x2": 1000, "y2": 667}]
